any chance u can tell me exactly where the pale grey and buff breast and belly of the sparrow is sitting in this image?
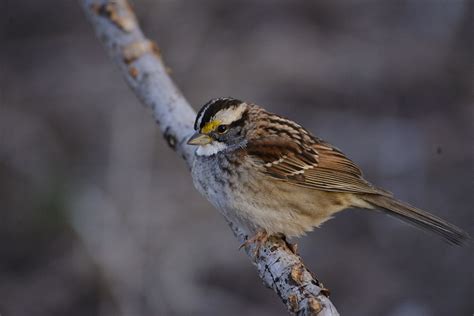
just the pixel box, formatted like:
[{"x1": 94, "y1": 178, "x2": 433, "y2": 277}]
[{"x1": 193, "y1": 155, "x2": 347, "y2": 237}]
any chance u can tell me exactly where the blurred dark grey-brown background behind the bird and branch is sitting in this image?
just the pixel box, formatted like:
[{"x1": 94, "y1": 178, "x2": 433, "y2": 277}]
[{"x1": 0, "y1": 0, "x2": 474, "y2": 316}]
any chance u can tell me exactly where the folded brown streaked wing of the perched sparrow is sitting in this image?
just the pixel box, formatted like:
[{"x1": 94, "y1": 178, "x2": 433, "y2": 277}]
[{"x1": 247, "y1": 136, "x2": 392, "y2": 196}]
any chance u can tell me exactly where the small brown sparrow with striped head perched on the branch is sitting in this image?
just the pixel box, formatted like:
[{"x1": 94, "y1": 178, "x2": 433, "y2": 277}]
[{"x1": 187, "y1": 97, "x2": 470, "y2": 251}]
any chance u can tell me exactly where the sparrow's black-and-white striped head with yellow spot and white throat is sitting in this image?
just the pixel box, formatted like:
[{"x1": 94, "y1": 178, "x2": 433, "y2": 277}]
[{"x1": 188, "y1": 98, "x2": 249, "y2": 156}]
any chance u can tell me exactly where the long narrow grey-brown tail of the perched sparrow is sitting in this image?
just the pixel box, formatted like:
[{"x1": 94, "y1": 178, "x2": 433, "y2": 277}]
[{"x1": 363, "y1": 194, "x2": 470, "y2": 245}]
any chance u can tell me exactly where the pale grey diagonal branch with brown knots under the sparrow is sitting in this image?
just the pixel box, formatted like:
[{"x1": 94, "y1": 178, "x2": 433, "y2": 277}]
[{"x1": 81, "y1": 0, "x2": 338, "y2": 316}]
